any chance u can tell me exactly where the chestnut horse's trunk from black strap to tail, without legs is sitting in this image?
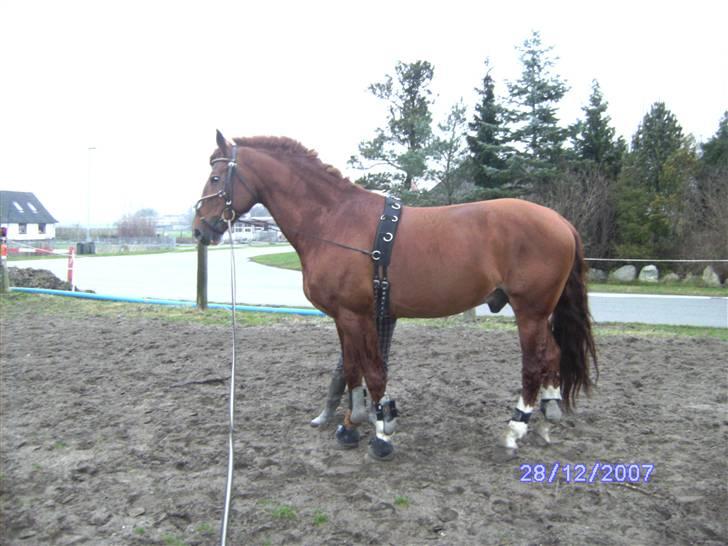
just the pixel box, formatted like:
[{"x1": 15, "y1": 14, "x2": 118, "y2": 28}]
[{"x1": 391, "y1": 199, "x2": 575, "y2": 316}]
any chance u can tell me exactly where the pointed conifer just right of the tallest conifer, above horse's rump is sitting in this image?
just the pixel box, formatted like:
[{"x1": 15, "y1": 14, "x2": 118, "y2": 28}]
[{"x1": 571, "y1": 80, "x2": 626, "y2": 177}]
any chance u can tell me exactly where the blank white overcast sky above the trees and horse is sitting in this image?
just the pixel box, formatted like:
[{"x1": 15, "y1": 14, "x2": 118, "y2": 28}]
[{"x1": 0, "y1": 0, "x2": 728, "y2": 224}]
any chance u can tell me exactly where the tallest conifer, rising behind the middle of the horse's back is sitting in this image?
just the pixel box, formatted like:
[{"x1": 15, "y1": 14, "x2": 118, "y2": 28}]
[{"x1": 508, "y1": 32, "x2": 568, "y2": 189}]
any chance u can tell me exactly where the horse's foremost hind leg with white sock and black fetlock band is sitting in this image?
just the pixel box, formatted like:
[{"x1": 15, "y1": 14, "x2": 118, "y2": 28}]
[{"x1": 502, "y1": 311, "x2": 559, "y2": 449}]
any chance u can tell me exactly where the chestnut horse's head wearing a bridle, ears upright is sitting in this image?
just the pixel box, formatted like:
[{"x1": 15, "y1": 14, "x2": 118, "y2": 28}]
[{"x1": 193, "y1": 131, "x2": 258, "y2": 245}]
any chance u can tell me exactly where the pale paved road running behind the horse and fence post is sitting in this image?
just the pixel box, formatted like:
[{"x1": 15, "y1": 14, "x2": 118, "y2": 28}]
[{"x1": 10, "y1": 245, "x2": 728, "y2": 328}]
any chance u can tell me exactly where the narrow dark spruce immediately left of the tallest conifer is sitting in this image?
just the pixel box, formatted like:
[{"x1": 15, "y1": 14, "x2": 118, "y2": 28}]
[{"x1": 467, "y1": 60, "x2": 509, "y2": 188}]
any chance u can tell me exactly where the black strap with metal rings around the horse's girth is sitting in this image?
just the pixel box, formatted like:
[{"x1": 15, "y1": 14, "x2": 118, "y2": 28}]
[{"x1": 371, "y1": 197, "x2": 404, "y2": 322}]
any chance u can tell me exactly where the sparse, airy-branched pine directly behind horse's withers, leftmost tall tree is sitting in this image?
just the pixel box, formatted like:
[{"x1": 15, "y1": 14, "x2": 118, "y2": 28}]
[{"x1": 349, "y1": 61, "x2": 434, "y2": 191}]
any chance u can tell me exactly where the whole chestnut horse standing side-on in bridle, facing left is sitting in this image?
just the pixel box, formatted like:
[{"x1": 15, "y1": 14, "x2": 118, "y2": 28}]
[{"x1": 194, "y1": 131, "x2": 596, "y2": 459}]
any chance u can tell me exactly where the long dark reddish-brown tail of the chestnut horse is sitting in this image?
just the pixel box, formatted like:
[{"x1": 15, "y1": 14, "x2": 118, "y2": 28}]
[{"x1": 551, "y1": 228, "x2": 599, "y2": 410}]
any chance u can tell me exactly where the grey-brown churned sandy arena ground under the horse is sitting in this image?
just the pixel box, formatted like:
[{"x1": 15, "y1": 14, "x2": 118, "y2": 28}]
[{"x1": 0, "y1": 296, "x2": 728, "y2": 545}]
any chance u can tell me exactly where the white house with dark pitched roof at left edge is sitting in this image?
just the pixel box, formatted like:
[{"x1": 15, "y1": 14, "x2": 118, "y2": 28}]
[{"x1": 0, "y1": 191, "x2": 58, "y2": 241}]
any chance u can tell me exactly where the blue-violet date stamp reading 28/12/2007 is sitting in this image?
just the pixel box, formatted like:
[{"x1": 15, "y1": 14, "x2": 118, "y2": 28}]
[{"x1": 518, "y1": 461, "x2": 655, "y2": 484}]
